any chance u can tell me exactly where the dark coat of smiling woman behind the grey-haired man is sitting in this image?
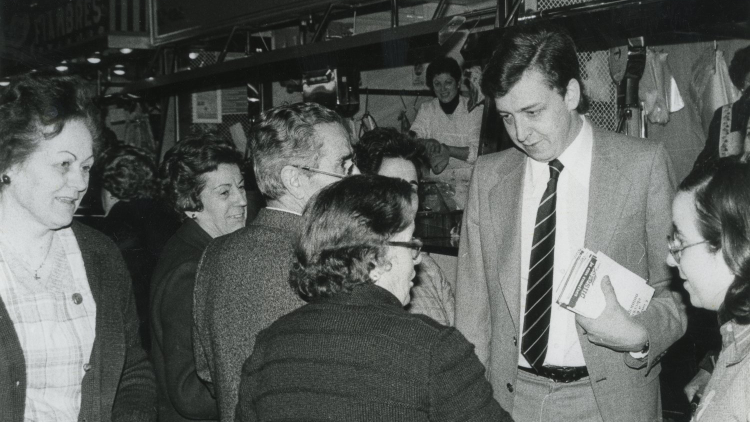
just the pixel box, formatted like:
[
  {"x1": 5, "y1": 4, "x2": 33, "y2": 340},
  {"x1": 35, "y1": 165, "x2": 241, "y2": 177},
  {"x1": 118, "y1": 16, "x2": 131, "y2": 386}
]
[{"x1": 151, "y1": 220, "x2": 219, "y2": 422}]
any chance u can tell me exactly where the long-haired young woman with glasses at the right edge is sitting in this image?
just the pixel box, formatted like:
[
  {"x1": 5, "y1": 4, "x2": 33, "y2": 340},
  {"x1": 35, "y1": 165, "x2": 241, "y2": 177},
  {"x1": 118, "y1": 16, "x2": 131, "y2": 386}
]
[{"x1": 667, "y1": 158, "x2": 750, "y2": 422}]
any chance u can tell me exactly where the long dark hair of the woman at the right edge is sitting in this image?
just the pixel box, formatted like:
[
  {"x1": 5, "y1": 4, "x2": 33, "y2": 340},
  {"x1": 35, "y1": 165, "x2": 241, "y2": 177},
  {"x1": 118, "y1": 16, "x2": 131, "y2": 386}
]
[{"x1": 679, "y1": 157, "x2": 750, "y2": 324}]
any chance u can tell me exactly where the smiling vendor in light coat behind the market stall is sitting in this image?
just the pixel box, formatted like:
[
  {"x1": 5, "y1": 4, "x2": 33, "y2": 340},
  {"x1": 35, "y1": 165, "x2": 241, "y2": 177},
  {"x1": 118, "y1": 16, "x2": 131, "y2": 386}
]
[{"x1": 411, "y1": 57, "x2": 483, "y2": 209}]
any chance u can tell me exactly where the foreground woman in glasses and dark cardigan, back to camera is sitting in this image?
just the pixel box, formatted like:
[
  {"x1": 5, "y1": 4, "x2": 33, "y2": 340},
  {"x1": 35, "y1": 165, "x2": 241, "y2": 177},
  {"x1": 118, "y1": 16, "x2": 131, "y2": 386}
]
[{"x1": 237, "y1": 175, "x2": 510, "y2": 422}]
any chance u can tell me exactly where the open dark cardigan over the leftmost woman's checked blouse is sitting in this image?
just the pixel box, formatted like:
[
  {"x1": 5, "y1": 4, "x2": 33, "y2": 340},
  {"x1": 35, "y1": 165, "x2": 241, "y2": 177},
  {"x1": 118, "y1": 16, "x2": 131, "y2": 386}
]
[{"x1": 0, "y1": 222, "x2": 156, "y2": 422}]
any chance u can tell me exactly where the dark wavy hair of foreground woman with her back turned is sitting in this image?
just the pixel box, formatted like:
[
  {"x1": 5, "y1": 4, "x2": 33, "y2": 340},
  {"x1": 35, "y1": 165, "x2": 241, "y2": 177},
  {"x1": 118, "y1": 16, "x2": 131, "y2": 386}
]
[{"x1": 290, "y1": 175, "x2": 416, "y2": 301}]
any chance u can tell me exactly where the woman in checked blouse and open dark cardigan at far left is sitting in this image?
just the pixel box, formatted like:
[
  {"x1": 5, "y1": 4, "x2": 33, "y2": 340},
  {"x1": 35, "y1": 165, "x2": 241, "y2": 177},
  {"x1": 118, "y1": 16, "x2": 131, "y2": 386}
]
[{"x1": 0, "y1": 75, "x2": 156, "y2": 422}]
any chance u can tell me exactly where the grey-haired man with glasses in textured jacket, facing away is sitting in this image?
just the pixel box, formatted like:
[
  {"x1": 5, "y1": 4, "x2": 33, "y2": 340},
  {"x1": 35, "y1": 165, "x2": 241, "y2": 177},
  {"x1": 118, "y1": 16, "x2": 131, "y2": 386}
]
[{"x1": 193, "y1": 103, "x2": 359, "y2": 422}]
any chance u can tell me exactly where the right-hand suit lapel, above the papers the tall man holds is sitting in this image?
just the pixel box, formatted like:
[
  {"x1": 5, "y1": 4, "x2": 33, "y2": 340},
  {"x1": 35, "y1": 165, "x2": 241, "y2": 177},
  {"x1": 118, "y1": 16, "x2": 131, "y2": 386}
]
[{"x1": 584, "y1": 127, "x2": 631, "y2": 252}]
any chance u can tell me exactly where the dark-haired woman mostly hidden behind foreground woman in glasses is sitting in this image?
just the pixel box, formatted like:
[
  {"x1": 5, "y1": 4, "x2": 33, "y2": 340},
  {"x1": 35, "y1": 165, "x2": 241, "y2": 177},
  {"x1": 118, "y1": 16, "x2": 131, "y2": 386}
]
[{"x1": 354, "y1": 128, "x2": 455, "y2": 326}]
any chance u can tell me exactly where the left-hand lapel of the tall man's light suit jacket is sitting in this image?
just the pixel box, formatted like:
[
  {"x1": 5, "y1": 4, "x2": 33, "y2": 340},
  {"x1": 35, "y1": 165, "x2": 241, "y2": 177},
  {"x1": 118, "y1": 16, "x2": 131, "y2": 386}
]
[{"x1": 489, "y1": 151, "x2": 526, "y2": 328}]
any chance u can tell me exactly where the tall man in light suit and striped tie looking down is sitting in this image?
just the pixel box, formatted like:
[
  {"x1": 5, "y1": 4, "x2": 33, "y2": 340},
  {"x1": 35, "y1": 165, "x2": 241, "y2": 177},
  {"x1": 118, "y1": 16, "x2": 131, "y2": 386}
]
[{"x1": 456, "y1": 25, "x2": 686, "y2": 422}]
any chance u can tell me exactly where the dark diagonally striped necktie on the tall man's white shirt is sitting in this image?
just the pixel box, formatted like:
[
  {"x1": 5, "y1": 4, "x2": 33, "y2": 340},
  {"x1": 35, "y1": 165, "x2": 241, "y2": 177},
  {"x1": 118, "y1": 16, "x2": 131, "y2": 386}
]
[{"x1": 521, "y1": 159, "x2": 563, "y2": 368}]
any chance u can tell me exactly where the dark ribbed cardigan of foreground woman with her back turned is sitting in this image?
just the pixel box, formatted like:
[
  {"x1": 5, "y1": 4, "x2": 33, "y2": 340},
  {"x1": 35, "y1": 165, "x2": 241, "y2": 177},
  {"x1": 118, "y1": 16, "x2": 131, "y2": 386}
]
[{"x1": 237, "y1": 284, "x2": 511, "y2": 422}]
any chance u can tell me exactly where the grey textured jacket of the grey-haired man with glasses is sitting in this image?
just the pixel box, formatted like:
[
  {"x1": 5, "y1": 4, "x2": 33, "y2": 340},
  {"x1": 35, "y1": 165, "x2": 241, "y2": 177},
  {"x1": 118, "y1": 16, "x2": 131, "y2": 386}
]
[{"x1": 193, "y1": 208, "x2": 304, "y2": 422}]
